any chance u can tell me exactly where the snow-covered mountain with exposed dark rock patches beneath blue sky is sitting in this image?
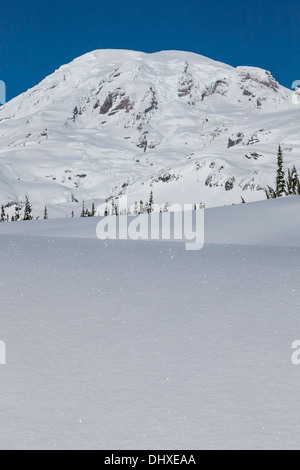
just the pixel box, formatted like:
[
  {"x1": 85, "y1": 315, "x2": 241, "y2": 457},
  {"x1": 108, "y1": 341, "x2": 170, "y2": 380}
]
[{"x1": 0, "y1": 50, "x2": 300, "y2": 215}]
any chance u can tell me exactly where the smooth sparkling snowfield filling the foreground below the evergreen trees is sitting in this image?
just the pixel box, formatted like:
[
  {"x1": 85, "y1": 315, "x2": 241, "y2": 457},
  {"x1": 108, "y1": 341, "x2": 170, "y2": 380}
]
[{"x1": 0, "y1": 197, "x2": 300, "y2": 449}]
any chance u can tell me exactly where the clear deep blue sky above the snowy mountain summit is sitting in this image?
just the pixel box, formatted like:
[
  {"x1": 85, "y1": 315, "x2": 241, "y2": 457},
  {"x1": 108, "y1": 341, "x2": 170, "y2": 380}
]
[{"x1": 0, "y1": 0, "x2": 300, "y2": 99}]
